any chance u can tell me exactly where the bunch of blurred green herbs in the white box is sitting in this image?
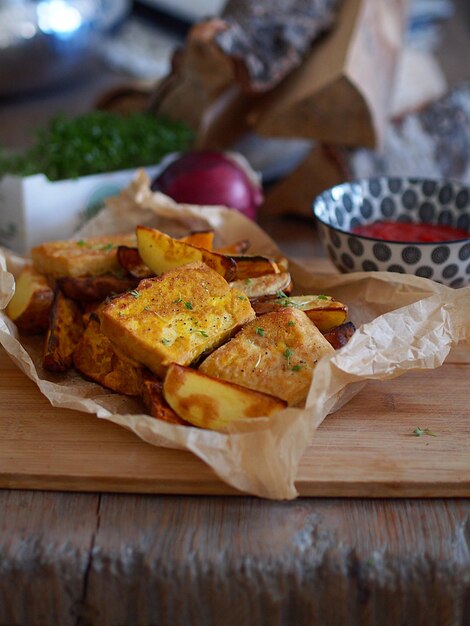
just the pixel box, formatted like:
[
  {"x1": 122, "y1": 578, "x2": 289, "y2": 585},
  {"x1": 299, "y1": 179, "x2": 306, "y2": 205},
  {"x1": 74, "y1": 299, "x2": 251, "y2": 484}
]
[{"x1": 0, "y1": 111, "x2": 194, "y2": 180}]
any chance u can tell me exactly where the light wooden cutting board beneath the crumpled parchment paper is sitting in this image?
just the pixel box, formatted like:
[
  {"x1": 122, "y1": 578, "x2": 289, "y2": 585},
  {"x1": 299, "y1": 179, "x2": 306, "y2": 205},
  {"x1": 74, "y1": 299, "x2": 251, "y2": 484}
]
[{"x1": 0, "y1": 348, "x2": 470, "y2": 497}]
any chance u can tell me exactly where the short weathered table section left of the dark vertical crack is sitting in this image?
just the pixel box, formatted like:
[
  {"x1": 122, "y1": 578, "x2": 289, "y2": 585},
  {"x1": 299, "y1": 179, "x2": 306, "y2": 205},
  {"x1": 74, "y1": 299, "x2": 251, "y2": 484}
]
[{"x1": 0, "y1": 490, "x2": 99, "y2": 626}]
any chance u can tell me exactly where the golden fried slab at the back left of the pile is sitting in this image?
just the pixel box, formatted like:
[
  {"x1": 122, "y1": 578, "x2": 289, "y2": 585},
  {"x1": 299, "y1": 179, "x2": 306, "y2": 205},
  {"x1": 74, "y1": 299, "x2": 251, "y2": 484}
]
[{"x1": 31, "y1": 234, "x2": 136, "y2": 278}]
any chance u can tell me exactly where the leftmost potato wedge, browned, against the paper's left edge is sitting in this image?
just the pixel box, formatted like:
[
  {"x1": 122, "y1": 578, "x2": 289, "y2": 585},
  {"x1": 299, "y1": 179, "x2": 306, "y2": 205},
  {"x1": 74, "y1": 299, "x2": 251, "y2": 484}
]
[{"x1": 6, "y1": 266, "x2": 54, "y2": 335}]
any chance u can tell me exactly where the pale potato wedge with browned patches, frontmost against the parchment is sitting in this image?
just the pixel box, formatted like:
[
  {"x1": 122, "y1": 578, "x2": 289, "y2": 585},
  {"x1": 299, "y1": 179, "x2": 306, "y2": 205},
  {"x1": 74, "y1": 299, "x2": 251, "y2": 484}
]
[{"x1": 163, "y1": 363, "x2": 287, "y2": 431}]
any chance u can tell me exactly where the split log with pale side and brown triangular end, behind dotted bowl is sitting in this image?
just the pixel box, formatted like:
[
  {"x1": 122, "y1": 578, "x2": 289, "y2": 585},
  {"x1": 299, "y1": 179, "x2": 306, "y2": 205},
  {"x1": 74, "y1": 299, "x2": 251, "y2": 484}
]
[{"x1": 249, "y1": 0, "x2": 407, "y2": 148}]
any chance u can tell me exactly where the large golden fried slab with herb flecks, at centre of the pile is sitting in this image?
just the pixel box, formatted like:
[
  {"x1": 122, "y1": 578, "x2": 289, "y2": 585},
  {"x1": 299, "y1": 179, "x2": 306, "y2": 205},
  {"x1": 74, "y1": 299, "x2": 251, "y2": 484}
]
[{"x1": 100, "y1": 263, "x2": 254, "y2": 377}]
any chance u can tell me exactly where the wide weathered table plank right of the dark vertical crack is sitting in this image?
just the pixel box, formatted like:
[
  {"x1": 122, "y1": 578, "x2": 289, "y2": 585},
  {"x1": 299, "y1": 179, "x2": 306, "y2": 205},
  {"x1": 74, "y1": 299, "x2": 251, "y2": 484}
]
[{"x1": 80, "y1": 496, "x2": 470, "y2": 626}]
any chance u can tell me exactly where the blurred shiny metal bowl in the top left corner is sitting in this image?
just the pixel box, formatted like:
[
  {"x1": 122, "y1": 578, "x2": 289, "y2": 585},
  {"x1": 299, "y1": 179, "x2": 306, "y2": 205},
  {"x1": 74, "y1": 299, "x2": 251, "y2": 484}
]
[{"x1": 0, "y1": 0, "x2": 130, "y2": 96}]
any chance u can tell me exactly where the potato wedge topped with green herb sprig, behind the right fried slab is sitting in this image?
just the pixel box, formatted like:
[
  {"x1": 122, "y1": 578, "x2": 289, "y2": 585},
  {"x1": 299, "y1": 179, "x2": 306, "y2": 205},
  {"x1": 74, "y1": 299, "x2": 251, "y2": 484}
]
[{"x1": 252, "y1": 293, "x2": 348, "y2": 332}]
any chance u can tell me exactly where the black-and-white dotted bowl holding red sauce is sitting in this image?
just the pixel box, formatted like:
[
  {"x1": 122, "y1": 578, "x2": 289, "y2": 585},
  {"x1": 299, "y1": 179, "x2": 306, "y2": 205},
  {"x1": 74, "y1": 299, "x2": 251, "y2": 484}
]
[{"x1": 313, "y1": 177, "x2": 470, "y2": 287}]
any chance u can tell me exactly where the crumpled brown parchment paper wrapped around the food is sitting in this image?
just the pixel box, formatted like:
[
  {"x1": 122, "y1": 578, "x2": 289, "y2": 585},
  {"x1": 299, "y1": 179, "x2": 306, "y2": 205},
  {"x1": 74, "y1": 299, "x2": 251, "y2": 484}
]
[{"x1": 0, "y1": 172, "x2": 470, "y2": 499}]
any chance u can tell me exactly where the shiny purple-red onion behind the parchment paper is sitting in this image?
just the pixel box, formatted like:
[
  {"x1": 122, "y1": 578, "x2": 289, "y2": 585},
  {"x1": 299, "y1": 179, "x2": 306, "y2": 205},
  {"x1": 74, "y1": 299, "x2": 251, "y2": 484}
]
[{"x1": 152, "y1": 150, "x2": 263, "y2": 219}]
